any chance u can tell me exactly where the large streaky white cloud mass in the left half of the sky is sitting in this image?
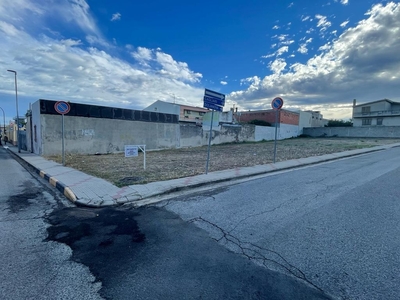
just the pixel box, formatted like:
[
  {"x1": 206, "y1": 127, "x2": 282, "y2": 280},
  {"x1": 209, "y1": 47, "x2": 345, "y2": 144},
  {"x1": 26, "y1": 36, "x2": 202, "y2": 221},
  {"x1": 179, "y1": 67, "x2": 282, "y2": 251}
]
[{"x1": 0, "y1": 0, "x2": 204, "y2": 109}]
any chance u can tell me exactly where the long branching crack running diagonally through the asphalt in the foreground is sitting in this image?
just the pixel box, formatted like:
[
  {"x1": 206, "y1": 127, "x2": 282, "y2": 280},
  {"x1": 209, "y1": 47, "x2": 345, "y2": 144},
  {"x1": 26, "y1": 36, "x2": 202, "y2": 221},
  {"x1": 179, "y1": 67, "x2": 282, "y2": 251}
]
[{"x1": 188, "y1": 217, "x2": 324, "y2": 292}]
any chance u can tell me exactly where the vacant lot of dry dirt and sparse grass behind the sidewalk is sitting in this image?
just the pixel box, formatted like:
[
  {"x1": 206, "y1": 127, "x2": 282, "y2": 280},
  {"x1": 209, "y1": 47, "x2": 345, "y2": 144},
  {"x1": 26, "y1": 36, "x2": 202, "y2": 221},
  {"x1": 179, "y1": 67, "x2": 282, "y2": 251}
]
[{"x1": 46, "y1": 138, "x2": 400, "y2": 186}]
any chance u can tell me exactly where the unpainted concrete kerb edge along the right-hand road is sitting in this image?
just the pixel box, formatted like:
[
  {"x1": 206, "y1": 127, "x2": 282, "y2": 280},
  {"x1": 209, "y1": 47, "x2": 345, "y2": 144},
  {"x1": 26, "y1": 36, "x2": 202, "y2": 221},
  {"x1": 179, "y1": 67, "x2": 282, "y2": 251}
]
[{"x1": 129, "y1": 145, "x2": 390, "y2": 204}]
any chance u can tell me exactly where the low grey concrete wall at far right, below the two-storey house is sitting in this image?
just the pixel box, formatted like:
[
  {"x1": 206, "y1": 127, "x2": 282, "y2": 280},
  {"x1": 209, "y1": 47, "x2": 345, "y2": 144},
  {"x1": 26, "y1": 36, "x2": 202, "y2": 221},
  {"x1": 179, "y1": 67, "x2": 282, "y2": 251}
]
[{"x1": 303, "y1": 126, "x2": 400, "y2": 138}]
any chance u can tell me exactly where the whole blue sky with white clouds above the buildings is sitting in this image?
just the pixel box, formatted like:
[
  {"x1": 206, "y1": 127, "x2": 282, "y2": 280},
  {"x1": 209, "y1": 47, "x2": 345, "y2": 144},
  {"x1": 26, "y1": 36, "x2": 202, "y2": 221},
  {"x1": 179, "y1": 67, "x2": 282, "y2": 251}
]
[{"x1": 0, "y1": 0, "x2": 400, "y2": 123}]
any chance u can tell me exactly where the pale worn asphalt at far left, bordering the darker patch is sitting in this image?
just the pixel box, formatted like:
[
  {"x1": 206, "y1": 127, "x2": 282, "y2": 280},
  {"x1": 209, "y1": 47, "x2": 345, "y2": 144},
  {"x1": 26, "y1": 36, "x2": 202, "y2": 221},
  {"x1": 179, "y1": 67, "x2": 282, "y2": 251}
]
[{"x1": 0, "y1": 148, "x2": 101, "y2": 300}]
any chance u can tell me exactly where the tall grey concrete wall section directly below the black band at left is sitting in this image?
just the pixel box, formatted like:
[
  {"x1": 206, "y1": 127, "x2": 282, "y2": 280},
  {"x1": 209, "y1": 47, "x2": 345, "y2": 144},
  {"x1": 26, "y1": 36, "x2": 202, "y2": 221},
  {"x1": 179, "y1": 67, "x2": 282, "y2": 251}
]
[{"x1": 39, "y1": 114, "x2": 179, "y2": 155}]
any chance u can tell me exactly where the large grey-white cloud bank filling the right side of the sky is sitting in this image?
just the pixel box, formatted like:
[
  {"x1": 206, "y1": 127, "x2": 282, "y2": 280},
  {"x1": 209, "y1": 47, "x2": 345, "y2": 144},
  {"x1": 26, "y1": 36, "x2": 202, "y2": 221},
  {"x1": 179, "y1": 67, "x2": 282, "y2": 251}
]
[{"x1": 228, "y1": 2, "x2": 400, "y2": 118}]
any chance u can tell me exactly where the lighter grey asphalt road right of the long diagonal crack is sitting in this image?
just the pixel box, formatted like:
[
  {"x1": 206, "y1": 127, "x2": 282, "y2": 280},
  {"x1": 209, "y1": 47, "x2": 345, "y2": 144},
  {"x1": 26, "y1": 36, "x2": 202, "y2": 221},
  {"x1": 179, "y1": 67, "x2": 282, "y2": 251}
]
[{"x1": 158, "y1": 148, "x2": 400, "y2": 300}]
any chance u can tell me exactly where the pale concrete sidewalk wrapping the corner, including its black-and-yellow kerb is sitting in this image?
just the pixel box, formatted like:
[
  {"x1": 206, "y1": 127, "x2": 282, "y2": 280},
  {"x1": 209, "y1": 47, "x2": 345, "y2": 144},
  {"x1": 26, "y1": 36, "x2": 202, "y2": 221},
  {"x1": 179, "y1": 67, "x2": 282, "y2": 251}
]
[{"x1": 4, "y1": 143, "x2": 400, "y2": 207}]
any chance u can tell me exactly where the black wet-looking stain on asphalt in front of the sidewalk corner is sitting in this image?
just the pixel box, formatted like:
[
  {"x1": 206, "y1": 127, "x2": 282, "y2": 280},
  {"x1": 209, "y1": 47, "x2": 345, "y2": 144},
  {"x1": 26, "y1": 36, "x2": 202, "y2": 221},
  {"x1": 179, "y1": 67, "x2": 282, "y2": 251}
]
[{"x1": 45, "y1": 207, "x2": 146, "y2": 299}]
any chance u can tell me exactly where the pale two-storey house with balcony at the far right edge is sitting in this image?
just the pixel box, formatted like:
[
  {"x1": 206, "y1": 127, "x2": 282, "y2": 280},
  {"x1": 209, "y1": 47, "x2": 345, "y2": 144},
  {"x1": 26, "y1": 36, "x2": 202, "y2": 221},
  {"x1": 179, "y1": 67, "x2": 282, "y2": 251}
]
[{"x1": 353, "y1": 99, "x2": 400, "y2": 127}]
